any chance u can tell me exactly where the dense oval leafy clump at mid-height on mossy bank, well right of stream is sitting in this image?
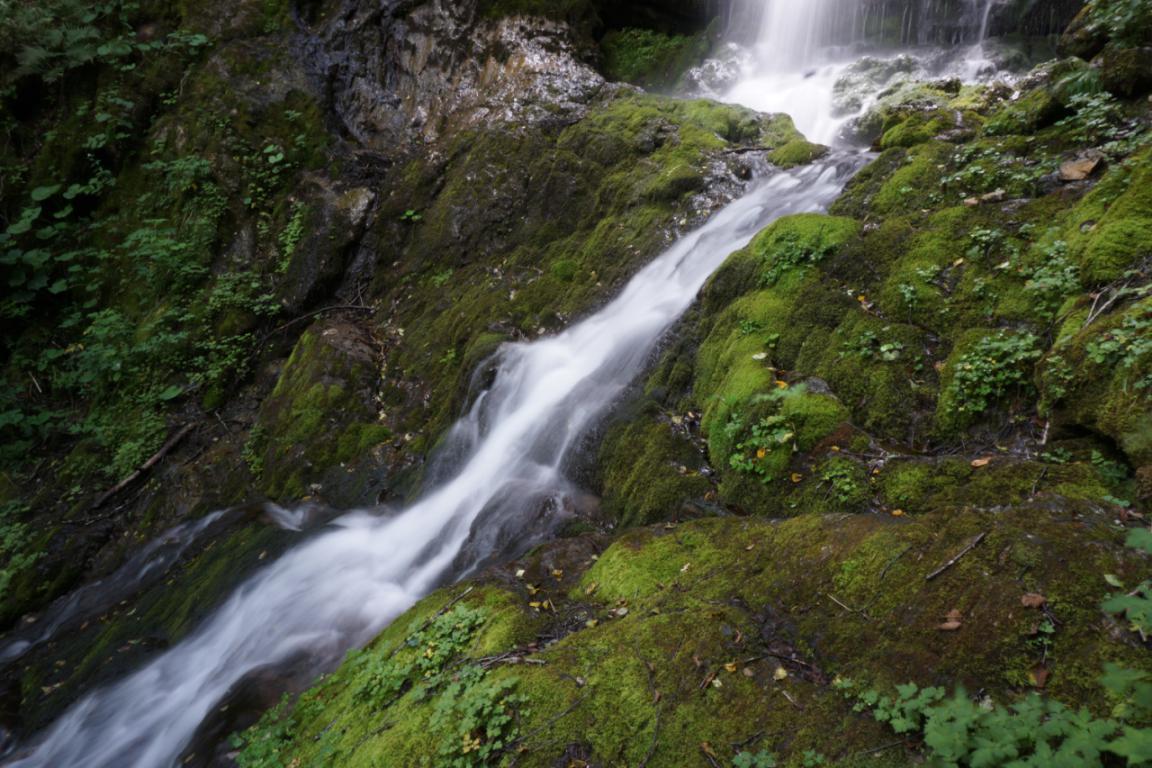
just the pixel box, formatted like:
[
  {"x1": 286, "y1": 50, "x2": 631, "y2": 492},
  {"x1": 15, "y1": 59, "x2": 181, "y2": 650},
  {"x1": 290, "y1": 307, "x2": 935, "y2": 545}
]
[{"x1": 949, "y1": 330, "x2": 1041, "y2": 415}]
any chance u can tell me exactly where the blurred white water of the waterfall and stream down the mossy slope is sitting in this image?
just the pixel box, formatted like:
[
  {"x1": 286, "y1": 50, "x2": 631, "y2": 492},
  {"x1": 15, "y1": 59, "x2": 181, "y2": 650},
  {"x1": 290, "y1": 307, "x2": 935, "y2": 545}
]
[{"x1": 7, "y1": 0, "x2": 1018, "y2": 768}]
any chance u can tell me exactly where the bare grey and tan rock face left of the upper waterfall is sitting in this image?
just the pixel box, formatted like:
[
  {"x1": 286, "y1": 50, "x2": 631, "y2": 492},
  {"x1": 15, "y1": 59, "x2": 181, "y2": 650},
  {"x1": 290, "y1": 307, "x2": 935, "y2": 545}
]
[{"x1": 312, "y1": 0, "x2": 604, "y2": 153}]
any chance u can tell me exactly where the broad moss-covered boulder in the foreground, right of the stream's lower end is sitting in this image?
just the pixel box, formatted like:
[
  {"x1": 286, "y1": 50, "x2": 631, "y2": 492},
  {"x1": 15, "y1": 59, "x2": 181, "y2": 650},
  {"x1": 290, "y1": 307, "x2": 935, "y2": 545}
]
[{"x1": 229, "y1": 504, "x2": 1147, "y2": 768}]
